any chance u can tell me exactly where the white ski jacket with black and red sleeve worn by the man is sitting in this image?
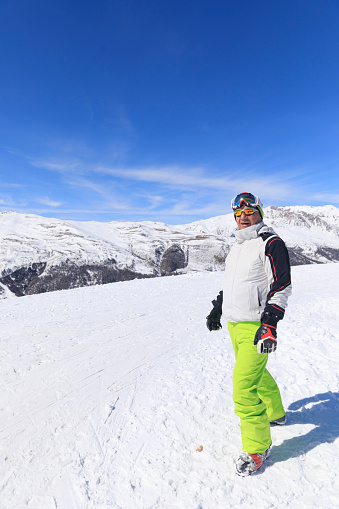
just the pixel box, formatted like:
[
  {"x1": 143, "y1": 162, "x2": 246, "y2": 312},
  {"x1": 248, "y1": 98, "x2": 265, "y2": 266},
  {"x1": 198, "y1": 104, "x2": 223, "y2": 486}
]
[{"x1": 222, "y1": 221, "x2": 292, "y2": 322}]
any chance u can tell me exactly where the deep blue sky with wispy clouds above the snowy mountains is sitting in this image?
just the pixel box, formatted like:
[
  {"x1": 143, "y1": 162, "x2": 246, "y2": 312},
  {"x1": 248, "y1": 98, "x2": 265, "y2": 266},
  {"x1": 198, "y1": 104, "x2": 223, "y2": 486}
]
[{"x1": 0, "y1": 0, "x2": 339, "y2": 224}]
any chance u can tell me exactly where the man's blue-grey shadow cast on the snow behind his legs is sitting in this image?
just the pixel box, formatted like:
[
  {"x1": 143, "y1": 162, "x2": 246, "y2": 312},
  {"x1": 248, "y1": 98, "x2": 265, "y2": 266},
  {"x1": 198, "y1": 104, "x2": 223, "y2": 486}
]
[{"x1": 271, "y1": 391, "x2": 339, "y2": 463}]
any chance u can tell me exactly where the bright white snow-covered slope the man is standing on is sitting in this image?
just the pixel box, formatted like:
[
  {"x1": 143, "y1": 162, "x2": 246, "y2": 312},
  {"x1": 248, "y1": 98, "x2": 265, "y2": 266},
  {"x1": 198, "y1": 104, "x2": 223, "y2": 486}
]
[{"x1": 0, "y1": 264, "x2": 339, "y2": 509}]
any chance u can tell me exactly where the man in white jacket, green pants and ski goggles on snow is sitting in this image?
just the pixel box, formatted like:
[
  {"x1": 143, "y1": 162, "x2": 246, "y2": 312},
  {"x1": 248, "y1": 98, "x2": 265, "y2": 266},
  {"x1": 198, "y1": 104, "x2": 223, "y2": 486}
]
[{"x1": 207, "y1": 193, "x2": 292, "y2": 476}]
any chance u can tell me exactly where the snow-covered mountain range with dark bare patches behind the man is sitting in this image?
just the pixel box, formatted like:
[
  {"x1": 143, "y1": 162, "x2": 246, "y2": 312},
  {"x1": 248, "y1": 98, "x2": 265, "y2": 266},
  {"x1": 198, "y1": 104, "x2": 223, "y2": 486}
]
[{"x1": 0, "y1": 206, "x2": 339, "y2": 295}]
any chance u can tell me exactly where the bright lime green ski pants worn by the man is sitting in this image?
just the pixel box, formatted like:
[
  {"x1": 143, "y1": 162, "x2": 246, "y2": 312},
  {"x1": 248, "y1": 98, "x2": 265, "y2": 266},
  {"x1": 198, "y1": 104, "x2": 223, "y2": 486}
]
[{"x1": 228, "y1": 322, "x2": 285, "y2": 454}]
